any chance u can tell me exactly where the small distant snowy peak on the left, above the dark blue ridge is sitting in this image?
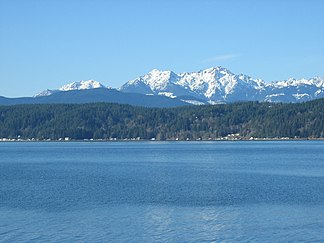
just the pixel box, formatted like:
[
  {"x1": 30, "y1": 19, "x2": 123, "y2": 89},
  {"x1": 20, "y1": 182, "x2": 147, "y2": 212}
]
[{"x1": 34, "y1": 80, "x2": 106, "y2": 97}]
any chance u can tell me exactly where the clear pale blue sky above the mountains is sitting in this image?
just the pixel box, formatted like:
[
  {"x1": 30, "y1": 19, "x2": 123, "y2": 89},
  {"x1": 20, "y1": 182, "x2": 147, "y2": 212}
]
[{"x1": 0, "y1": 0, "x2": 324, "y2": 97}]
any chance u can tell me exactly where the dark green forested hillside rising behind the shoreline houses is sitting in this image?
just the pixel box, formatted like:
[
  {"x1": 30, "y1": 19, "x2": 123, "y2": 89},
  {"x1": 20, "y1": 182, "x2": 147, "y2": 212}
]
[{"x1": 0, "y1": 99, "x2": 324, "y2": 140}]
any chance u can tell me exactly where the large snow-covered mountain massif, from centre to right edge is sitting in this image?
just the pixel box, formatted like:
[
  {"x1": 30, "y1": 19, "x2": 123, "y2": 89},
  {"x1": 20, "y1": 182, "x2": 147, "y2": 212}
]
[{"x1": 120, "y1": 66, "x2": 324, "y2": 104}]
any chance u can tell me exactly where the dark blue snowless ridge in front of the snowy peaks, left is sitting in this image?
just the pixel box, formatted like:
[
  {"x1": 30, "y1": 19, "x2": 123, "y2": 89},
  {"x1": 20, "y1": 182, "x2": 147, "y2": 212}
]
[{"x1": 0, "y1": 88, "x2": 189, "y2": 107}]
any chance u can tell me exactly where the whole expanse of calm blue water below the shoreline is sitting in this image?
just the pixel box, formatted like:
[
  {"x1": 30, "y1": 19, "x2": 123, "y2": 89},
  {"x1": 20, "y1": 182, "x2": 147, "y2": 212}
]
[{"x1": 0, "y1": 141, "x2": 324, "y2": 242}]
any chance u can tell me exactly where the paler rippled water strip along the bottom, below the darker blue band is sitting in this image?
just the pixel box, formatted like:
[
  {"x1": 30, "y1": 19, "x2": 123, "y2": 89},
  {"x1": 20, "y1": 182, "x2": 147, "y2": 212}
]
[{"x1": 0, "y1": 205, "x2": 324, "y2": 242}]
